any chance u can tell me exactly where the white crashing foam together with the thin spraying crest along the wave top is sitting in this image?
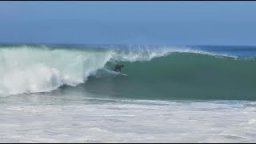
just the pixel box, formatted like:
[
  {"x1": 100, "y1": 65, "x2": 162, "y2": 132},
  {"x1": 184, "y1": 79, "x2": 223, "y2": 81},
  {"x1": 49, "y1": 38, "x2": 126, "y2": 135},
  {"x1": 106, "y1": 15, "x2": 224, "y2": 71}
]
[{"x1": 0, "y1": 45, "x2": 249, "y2": 96}]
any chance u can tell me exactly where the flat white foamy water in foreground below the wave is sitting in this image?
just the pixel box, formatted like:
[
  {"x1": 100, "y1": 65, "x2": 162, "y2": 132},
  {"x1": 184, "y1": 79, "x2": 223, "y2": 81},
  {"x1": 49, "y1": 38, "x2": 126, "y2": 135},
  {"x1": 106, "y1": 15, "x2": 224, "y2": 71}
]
[{"x1": 0, "y1": 100, "x2": 256, "y2": 142}]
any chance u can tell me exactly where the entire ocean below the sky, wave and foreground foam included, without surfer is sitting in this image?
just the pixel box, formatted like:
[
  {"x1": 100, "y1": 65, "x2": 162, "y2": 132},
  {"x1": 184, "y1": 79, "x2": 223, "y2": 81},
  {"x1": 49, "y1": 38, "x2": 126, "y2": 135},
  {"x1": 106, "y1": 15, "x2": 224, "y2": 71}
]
[{"x1": 0, "y1": 44, "x2": 256, "y2": 142}]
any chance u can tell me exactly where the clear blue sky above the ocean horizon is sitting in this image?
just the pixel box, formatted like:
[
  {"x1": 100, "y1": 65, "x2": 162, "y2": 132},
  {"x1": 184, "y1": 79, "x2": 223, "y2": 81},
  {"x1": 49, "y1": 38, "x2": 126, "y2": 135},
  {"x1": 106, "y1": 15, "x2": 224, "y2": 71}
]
[{"x1": 0, "y1": 1, "x2": 256, "y2": 45}]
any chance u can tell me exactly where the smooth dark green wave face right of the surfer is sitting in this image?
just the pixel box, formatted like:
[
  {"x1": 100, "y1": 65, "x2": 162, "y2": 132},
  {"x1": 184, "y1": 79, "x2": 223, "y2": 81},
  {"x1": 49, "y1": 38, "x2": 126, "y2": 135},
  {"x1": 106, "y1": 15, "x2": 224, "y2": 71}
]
[{"x1": 83, "y1": 53, "x2": 256, "y2": 100}]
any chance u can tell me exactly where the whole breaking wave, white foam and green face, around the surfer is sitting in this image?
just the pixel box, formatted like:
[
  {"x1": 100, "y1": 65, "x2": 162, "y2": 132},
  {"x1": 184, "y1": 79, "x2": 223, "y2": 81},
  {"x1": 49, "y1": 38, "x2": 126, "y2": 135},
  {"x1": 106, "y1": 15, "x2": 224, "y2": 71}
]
[{"x1": 0, "y1": 45, "x2": 256, "y2": 100}]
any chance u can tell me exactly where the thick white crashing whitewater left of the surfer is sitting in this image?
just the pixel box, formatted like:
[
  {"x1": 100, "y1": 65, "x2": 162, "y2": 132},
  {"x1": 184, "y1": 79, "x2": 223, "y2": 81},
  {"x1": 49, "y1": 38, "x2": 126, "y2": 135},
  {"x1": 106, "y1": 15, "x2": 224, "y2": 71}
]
[{"x1": 0, "y1": 46, "x2": 113, "y2": 95}]
